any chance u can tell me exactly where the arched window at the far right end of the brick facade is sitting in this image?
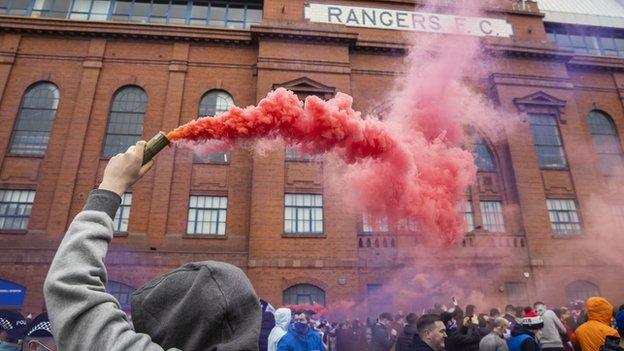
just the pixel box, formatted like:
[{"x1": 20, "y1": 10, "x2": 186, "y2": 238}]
[{"x1": 587, "y1": 111, "x2": 624, "y2": 174}]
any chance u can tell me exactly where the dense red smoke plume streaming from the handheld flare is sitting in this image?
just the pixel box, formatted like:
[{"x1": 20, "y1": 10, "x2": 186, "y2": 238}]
[{"x1": 167, "y1": 89, "x2": 476, "y2": 245}]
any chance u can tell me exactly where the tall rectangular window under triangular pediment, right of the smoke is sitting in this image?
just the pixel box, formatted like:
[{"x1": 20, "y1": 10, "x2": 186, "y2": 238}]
[{"x1": 529, "y1": 114, "x2": 567, "y2": 168}]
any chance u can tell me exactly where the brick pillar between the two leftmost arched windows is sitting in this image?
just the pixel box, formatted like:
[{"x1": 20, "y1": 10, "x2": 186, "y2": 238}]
[{"x1": 47, "y1": 38, "x2": 106, "y2": 235}]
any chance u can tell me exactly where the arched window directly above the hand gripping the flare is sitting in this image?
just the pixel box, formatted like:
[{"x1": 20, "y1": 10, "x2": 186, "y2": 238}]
[{"x1": 102, "y1": 86, "x2": 147, "y2": 157}]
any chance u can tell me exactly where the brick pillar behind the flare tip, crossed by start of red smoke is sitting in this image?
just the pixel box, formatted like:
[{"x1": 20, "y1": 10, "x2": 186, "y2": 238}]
[{"x1": 147, "y1": 43, "x2": 190, "y2": 237}]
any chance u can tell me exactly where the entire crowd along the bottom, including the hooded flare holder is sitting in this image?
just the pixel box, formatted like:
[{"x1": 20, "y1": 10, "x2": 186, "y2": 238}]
[{"x1": 0, "y1": 141, "x2": 624, "y2": 351}]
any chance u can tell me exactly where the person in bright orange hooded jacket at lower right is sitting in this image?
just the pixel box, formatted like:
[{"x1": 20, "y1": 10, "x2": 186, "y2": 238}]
[{"x1": 575, "y1": 297, "x2": 620, "y2": 351}]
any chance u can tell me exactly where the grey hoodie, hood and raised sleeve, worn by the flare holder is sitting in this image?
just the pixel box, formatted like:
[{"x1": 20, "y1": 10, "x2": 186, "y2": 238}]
[{"x1": 44, "y1": 190, "x2": 261, "y2": 351}]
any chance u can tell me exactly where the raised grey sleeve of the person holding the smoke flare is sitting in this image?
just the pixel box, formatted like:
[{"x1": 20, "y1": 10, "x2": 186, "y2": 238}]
[{"x1": 44, "y1": 190, "x2": 173, "y2": 351}]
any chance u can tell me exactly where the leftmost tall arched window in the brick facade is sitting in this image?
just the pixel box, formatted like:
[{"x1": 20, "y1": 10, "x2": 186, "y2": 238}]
[{"x1": 9, "y1": 82, "x2": 59, "y2": 155}]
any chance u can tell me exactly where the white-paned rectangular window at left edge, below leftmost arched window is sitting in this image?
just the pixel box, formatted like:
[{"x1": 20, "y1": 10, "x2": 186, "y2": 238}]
[{"x1": 0, "y1": 189, "x2": 35, "y2": 231}]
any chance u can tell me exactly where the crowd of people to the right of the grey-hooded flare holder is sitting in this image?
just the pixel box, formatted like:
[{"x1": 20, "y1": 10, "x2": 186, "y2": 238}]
[{"x1": 261, "y1": 297, "x2": 624, "y2": 351}]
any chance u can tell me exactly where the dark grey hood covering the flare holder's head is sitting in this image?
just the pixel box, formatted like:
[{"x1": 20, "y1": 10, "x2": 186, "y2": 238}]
[{"x1": 131, "y1": 261, "x2": 262, "y2": 351}]
